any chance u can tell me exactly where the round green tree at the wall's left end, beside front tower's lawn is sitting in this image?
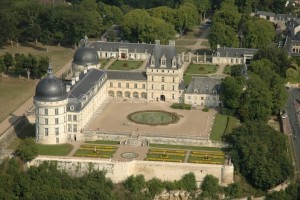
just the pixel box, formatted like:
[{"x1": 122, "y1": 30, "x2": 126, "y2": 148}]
[{"x1": 16, "y1": 138, "x2": 38, "y2": 162}]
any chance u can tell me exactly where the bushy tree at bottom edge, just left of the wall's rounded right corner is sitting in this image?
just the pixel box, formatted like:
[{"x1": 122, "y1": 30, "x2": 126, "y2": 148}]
[{"x1": 201, "y1": 175, "x2": 221, "y2": 199}]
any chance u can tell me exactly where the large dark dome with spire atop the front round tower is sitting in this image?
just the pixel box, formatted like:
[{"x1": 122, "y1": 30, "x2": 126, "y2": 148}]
[{"x1": 34, "y1": 65, "x2": 67, "y2": 102}]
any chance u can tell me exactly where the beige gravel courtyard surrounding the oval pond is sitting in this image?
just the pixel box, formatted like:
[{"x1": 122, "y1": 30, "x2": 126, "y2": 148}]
[{"x1": 87, "y1": 99, "x2": 216, "y2": 138}]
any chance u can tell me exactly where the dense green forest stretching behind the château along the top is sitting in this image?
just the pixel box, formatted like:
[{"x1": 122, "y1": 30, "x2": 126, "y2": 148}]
[{"x1": 0, "y1": 0, "x2": 290, "y2": 47}]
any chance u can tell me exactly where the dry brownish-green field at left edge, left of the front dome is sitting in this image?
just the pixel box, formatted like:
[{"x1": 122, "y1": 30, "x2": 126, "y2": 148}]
[{"x1": 0, "y1": 77, "x2": 36, "y2": 122}]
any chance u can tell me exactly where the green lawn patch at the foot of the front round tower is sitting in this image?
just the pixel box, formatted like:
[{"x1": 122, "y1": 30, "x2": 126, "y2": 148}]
[{"x1": 37, "y1": 144, "x2": 73, "y2": 156}]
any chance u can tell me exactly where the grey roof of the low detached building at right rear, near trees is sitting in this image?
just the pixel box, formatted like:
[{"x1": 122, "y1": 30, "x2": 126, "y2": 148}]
[{"x1": 213, "y1": 47, "x2": 258, "y2": 58}]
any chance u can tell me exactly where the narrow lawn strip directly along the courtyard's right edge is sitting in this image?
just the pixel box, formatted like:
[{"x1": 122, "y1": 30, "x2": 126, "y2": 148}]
[{"x1": 210, "y1": 113, "x2": 228, "y2": 141}]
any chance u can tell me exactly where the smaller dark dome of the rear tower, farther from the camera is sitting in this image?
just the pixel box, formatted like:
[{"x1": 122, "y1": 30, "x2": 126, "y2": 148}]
[{"x1": 73, "y1": 45, "x2": 100, "y2": 65}]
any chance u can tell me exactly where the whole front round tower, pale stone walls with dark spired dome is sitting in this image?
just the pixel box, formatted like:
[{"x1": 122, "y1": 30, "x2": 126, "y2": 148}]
[{"x1": 34, "y1": 64, "x2": 68, "y2": 144}]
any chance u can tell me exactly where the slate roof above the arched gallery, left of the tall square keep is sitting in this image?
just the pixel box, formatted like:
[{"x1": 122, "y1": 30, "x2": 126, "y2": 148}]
[{"x1": 107, "y1": 70, "x2": 147, "y2": 81}]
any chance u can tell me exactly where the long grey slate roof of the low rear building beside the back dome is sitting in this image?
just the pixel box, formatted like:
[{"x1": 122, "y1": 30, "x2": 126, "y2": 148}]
[{"x1": 90, "y1": 41, "x2": 155, "y2": 53}]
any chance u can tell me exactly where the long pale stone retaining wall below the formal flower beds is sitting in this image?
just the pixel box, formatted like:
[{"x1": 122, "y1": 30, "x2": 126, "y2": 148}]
[{"x1": 28, "y1": 156, "x2": 234, "y2": 185}]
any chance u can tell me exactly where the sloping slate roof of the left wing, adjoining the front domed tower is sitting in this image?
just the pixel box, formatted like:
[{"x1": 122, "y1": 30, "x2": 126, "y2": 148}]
[{"x1": 68, "y1": 69, "x2": 106, "y2": 111}]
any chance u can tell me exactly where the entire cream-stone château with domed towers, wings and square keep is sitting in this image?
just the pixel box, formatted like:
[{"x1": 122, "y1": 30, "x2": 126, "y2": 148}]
[{"x1": 34, "y1": 41, "x2": 220, "y2": 144}]
